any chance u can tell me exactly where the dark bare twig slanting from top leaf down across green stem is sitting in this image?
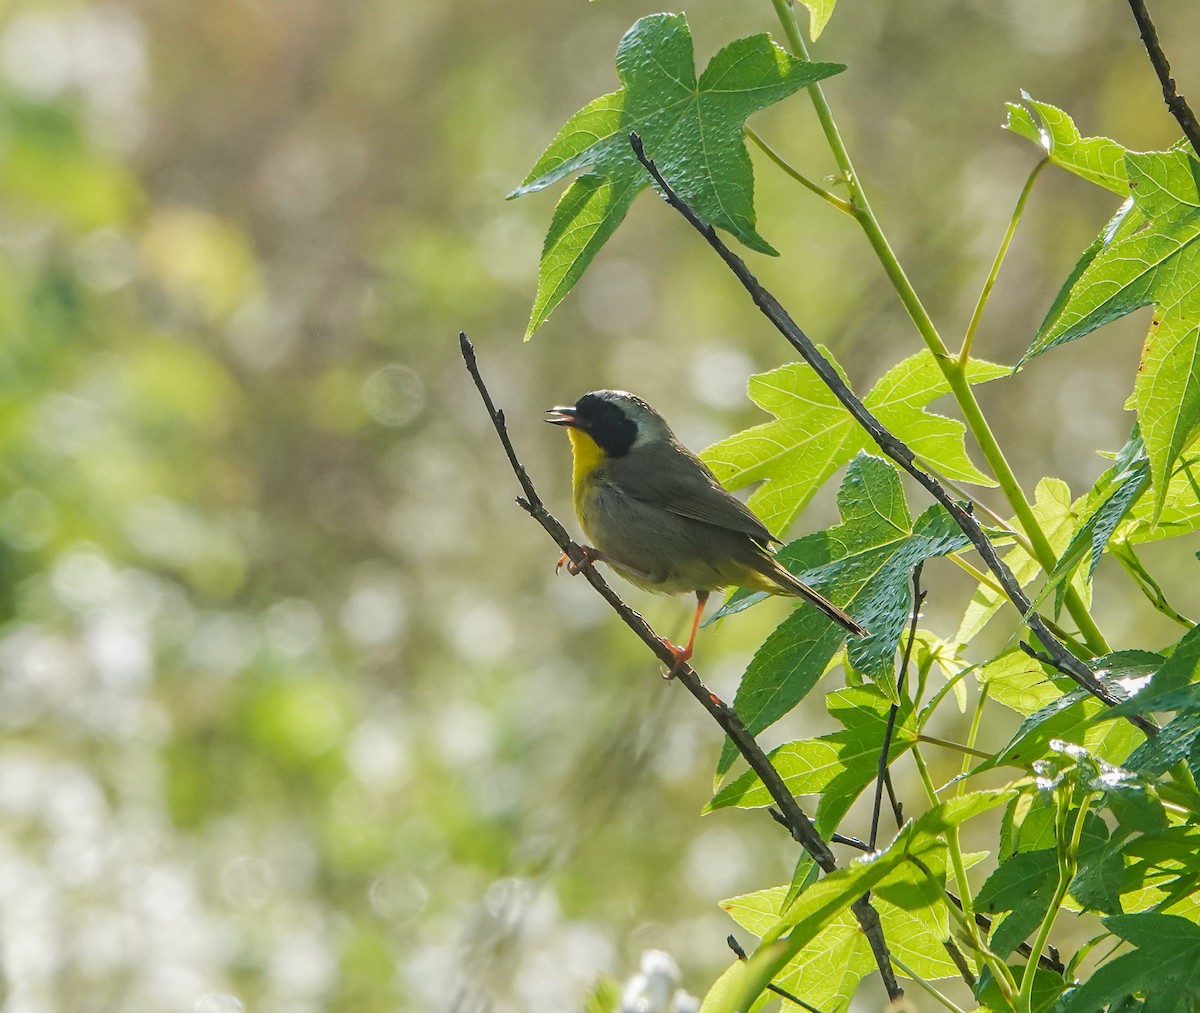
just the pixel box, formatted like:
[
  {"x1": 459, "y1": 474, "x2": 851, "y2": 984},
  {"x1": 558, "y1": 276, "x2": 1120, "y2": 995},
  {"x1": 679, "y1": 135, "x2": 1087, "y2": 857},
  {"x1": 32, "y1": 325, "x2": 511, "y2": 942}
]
[{"x1": 629, "y1": 133, "x2": 1158, "y2": 735}]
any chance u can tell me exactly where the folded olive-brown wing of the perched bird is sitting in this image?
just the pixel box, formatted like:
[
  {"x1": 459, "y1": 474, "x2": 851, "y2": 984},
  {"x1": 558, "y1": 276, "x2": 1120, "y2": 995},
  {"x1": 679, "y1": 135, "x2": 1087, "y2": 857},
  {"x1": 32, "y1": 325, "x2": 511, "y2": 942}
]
[{"x1": 608, "y1": 443, "x2": 779, "y2": 545}]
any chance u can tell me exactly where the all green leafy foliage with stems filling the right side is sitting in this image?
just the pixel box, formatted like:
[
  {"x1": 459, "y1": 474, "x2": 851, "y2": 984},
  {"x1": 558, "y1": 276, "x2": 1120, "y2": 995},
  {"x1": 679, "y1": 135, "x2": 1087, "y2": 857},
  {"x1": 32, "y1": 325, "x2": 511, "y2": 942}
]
[{"x1": 515, "y1": 4, "x2": 1200, "y2": 1013}]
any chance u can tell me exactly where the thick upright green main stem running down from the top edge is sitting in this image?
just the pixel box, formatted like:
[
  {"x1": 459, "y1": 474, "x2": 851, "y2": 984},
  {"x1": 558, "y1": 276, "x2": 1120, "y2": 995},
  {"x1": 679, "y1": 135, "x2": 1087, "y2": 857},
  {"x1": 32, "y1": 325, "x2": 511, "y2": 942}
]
[{"x1": 772, "y1": 0, "x2": 1110, "y2": 654}]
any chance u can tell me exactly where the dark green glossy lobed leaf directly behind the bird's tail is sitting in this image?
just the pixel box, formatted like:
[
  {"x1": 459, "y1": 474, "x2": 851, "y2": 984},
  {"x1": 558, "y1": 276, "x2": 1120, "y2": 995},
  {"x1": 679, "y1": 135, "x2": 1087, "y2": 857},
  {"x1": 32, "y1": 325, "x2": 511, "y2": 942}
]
[{"x1": 718, "y1": 454, "x2": 968, "y2": 775}]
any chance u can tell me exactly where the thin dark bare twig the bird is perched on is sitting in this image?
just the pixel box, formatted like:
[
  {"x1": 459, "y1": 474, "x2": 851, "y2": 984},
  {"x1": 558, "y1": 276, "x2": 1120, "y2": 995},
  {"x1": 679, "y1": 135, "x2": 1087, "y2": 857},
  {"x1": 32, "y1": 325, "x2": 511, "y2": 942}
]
[{"x1": 458, "y1": 334, "x2": 904, "y2": 1002}]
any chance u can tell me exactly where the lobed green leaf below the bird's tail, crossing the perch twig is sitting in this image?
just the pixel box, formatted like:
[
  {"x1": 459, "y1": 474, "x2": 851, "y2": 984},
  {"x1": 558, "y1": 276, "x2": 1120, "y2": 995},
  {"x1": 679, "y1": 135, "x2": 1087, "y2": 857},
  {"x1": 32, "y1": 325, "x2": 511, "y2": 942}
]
[{"x1": 704, "y1": 687, "x2": 916, "y2": 834}]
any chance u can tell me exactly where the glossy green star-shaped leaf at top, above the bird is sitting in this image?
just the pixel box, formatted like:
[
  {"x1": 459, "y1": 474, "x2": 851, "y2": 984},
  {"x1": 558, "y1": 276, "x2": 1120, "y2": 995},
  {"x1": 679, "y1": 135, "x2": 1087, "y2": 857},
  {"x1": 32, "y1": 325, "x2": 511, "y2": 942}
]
[{"x1": 509, "y1": 14, "x2": 845, "y2": 337}]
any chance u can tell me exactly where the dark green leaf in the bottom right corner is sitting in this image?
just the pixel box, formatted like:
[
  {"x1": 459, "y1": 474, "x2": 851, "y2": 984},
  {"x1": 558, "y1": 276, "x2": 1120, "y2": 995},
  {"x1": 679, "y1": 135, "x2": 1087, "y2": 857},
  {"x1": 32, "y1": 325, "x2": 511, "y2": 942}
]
[{"x1": 1061, "y1": 913, "x2": 1200, "y2": 1013}]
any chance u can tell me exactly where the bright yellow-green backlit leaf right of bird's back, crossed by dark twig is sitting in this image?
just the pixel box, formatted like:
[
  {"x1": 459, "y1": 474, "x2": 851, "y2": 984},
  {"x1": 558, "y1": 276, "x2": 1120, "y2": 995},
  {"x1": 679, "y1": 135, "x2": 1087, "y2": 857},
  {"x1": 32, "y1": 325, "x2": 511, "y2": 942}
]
[{"x1": 701, "y1": 348, "x2": 1012, "y2": 534}]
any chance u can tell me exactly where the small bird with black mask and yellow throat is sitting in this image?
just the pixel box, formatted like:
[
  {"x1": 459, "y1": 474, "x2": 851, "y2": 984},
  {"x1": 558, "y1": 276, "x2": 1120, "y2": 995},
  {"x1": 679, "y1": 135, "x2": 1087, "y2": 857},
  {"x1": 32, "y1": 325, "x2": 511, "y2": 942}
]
[{"x1": 545, "y1": 390, "x2": 869, "y2": 677}]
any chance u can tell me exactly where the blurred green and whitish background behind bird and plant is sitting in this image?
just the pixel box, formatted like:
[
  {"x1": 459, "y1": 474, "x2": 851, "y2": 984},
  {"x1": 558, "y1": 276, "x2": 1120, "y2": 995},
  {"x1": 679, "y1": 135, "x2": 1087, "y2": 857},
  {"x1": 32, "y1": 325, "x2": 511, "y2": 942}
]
[{"x1": 0, "y1": 0, "x2": 1200, "y2": 1013}]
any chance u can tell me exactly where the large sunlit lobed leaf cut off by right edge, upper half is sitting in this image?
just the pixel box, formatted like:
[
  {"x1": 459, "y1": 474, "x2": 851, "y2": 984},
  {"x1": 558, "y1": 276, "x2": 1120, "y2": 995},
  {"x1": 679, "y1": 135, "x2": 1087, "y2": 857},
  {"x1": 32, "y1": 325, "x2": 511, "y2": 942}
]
[{"x1": 1022, "y1": 149, "x2": 1200, "y2": 515}]
